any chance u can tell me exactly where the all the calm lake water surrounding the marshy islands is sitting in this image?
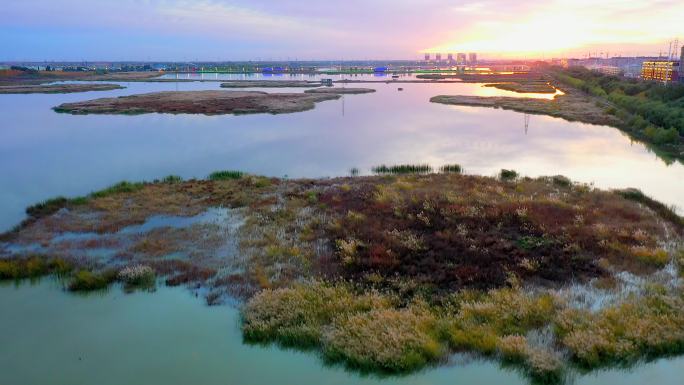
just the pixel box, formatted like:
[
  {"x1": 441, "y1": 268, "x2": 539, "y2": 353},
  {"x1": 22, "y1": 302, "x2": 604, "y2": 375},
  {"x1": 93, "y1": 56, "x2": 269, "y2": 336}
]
[{"x1": 0, "y1": 75, "x2": 684, "y2": 385}]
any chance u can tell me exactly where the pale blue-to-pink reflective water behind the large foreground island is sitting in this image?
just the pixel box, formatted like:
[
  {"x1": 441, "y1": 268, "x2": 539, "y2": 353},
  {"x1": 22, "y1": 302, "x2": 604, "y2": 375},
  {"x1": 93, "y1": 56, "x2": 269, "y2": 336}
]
[{"x1": 0, "y1": 74, "x2": 684, "y2": 231}]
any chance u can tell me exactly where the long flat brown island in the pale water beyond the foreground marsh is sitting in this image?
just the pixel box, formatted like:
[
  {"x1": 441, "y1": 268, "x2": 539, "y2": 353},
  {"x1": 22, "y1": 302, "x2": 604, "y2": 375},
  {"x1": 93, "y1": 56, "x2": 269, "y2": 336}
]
[{"x1": 54, "y1": 91, "x2": 340, "y2": 115}]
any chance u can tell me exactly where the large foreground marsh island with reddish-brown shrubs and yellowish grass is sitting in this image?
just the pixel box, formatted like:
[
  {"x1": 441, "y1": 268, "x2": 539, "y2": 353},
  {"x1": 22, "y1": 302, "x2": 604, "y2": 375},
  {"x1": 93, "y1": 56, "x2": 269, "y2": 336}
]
[{"x1": 0, "y1": 165, "x2": 684, "y2": 383}]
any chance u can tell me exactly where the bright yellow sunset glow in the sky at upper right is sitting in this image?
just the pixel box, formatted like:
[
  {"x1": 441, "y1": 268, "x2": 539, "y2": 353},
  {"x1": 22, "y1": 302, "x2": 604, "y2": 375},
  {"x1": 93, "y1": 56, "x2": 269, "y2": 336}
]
[{"x1": 422, "y1": 0, "x2": 684, "y2": 56}]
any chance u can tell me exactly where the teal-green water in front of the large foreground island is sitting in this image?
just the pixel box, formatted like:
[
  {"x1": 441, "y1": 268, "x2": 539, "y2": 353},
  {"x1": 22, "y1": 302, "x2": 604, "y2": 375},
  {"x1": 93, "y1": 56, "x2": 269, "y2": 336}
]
[{"x1": 0, "y1": 279, "x2": 684, "y2": 385}]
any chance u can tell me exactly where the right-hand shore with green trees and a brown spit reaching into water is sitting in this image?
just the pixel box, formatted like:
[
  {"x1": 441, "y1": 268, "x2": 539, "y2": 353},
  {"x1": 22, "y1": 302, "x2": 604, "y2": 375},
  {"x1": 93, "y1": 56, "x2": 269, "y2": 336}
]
[{"x1": 431, "y1": 68, "x2": 684, "y2": 161}]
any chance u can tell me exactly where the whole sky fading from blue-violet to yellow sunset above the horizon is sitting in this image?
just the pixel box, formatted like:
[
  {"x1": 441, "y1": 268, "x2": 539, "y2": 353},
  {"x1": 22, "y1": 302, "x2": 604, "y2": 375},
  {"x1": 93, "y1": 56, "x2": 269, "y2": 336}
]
[{"x1": 0, "y1": 0, "x2": 684, "y2": 61}]
